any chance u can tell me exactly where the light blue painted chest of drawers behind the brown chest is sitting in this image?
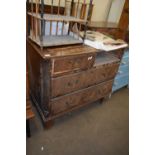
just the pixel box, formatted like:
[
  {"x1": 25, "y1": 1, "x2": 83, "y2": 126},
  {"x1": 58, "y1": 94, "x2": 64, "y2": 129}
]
[{"x1": 112, "y1": 49, "x2": 129, "y2": 92}]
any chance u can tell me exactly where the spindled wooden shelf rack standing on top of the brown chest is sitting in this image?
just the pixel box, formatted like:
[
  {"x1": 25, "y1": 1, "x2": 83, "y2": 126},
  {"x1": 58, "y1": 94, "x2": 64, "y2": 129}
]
[{"x1": 27, "y1": 0, "x2": 93, "y2": 48}]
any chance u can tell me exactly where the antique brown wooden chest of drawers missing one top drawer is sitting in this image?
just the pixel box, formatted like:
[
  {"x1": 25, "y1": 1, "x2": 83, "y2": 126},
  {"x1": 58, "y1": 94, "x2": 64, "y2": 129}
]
[{"x1": 26, "y1": 40, "x2": 123, "y2": 127}]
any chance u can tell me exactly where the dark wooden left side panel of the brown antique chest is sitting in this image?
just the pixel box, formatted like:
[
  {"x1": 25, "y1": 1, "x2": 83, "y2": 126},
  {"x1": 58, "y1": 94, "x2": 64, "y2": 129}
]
[{"x1": 26, "y1": 42, "x2": 51, "y2": 116}]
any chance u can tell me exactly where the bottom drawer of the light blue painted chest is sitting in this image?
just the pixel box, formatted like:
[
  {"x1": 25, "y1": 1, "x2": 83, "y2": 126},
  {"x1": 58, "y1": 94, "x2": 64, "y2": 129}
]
[{"x1": 112, "y1": 74, "x2": 129, "y2": 92}]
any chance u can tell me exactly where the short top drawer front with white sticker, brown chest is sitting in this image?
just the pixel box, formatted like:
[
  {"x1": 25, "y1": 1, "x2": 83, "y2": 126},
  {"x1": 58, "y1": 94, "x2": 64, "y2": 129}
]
[{"x1": 52, "y1": 53, "x2": 95, "y2": 77}]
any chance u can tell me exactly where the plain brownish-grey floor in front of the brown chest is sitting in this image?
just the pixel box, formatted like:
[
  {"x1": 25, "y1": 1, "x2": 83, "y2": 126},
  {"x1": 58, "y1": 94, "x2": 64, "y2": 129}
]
[{"x1": 26, "y1": 88, "x2": 129, "y2": 155}]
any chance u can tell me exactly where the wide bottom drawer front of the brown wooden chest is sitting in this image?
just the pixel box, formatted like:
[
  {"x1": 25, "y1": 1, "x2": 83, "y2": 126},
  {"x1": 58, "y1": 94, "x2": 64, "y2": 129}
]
[{"x1": 50, "y1": 80, "x2": 113, "y2": 115}]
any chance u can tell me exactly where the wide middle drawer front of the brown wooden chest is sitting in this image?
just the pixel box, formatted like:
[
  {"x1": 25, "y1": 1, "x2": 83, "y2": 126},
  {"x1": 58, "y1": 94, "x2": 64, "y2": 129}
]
[{"x1": 51, "y1": 63, "x2": 119, "y2": 97}]
